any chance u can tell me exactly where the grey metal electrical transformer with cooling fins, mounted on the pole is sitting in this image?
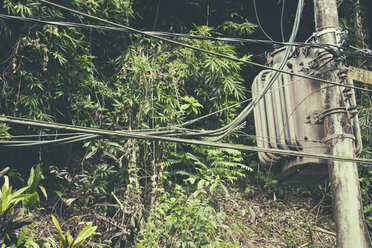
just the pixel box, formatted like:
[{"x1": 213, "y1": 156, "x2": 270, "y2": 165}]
[{"x1": 252, "y1": 47, "x2": 362, "y2": 183}]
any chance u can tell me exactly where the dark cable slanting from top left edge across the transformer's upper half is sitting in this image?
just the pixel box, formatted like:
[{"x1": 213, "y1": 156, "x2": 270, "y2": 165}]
[{"x1": 35, "y1": 0, "x2": 372, "y2": 92}]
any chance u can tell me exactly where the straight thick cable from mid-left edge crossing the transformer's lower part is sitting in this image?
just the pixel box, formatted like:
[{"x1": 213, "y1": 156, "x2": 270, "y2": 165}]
[{"x1": 0, "y1": 116, "x2": 372, "y2": 164}]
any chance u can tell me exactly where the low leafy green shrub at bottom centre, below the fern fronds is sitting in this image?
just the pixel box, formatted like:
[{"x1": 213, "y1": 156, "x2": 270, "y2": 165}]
[{"x1": 137, "y1": 183, "x2": 239, "y2": 247}]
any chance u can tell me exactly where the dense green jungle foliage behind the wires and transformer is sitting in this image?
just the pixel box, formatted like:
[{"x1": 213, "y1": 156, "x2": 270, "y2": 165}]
[{"x1": 0, "y1": 0, "x2": 372, "y2": 247}]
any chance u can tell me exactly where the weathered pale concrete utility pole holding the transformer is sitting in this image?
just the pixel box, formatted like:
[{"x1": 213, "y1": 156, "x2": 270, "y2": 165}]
[{"x1": 314, "y1": 0, "x2": 368, "y2": 248}]
